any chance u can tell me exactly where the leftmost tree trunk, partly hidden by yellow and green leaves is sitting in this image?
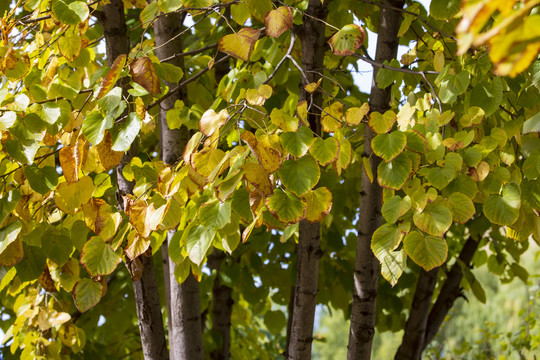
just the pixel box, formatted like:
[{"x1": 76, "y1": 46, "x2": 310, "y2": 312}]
[{"x1": 101, "y1": 0, "x2": 169, "y2": 360}]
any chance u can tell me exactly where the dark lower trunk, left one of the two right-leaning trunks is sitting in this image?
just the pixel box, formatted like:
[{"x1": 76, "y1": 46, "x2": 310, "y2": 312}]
[{"x1": 395, "y1": 268, "x2": 439, "y2": 360}]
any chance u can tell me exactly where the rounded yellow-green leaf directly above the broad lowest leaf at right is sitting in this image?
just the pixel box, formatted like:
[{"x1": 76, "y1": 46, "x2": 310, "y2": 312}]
[{"x1": 414, "y1": 201, "x2": 452, "y2": 236}]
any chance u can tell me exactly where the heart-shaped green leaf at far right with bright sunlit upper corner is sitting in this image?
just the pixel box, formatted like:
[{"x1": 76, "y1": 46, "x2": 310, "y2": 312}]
[{"x1": 484, "y1": 183, "x2": 521, "y2": 225}]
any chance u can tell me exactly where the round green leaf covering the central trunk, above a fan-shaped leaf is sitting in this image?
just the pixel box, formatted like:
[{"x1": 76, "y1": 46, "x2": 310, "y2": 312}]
[{"x1": 278, "y1": 155, "x2": 321, "y2": 196}]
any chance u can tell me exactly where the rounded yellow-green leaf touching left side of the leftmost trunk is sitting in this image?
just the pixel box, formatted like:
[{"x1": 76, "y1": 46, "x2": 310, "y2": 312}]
[{"x1": 81, "y1": 236, "x2": 122, "y2": 276}]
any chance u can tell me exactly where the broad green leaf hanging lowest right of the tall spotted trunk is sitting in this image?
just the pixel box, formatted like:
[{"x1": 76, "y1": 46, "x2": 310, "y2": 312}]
[{"x1": 403, "y1": 231, "x2": 448, "y2": 271}]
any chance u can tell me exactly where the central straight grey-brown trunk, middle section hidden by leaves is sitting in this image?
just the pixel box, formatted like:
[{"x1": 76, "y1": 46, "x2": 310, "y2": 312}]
[{"x1": 285, "y1": 0, "x2": 326, "y2": 360}]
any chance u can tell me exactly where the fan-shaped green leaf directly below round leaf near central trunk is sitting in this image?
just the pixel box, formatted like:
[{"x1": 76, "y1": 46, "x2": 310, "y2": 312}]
[{"x1": 265, "y1": 189, "x2": 306, "y2": 224}]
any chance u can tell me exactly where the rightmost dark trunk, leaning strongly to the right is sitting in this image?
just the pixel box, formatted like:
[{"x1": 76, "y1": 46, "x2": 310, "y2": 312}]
[{"x1": 422, "y1": 237, "x2": 479, "y2": 350}]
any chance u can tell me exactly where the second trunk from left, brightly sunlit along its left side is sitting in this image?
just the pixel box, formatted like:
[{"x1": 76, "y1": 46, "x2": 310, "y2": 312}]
[{"x1": 154, "y1": 13, "x2": 203, "y2": 360}]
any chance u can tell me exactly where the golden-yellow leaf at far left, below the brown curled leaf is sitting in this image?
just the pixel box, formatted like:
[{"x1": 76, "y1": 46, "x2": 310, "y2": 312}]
[{"x1": 54, "y1": 176, "x2": 94, "y2": 215}]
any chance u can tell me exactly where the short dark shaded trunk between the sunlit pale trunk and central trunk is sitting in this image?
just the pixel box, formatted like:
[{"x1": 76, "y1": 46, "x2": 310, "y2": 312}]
[{"x1": 208, "y1": 249, "x2": 234, "y2": 360}]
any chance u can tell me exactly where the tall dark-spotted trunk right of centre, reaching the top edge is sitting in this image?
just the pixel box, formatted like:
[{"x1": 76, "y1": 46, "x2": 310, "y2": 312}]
[{"x1": 347, "y1": 1, "x2": 404, "y2": 360}]
